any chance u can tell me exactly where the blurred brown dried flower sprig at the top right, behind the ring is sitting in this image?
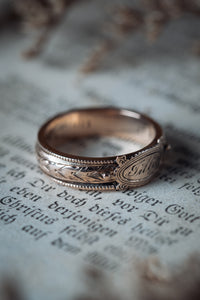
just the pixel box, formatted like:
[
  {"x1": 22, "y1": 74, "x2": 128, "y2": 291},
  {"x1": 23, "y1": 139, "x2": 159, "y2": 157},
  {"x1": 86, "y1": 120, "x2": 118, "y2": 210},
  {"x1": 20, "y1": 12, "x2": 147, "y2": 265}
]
[{"x1": 81, "y1": 0, "x2": 200, "y2": 73}]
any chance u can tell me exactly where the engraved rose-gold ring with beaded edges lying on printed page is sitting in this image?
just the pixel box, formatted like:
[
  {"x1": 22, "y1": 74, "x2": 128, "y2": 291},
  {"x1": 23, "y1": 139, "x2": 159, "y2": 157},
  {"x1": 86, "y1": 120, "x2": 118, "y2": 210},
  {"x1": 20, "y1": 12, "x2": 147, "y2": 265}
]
[{"x1": 36, "y1": 107, "x2": 166, "y2": 190}]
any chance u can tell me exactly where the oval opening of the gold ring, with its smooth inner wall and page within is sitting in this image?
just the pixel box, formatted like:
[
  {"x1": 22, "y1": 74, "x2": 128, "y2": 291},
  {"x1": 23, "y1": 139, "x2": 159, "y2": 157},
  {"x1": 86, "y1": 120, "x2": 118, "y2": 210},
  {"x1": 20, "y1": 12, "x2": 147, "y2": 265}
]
[{"x1": 43, "y1": 110, "x2": 156, "y2": 157}]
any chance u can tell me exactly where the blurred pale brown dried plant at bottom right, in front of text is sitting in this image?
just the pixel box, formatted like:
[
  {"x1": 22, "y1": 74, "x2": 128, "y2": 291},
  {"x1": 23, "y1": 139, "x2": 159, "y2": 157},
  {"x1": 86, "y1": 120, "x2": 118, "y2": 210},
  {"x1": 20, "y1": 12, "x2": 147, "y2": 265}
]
[{"x1": 76, "y1": 255, "x2": 200, "y2": 300}]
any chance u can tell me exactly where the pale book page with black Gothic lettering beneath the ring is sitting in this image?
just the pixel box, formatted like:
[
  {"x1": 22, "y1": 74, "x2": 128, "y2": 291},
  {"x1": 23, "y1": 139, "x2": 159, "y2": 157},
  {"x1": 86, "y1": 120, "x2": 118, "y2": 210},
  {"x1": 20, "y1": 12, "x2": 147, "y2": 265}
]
[{"x1": 0, "y1": 3, "x2": 200, "y2": 300}]
